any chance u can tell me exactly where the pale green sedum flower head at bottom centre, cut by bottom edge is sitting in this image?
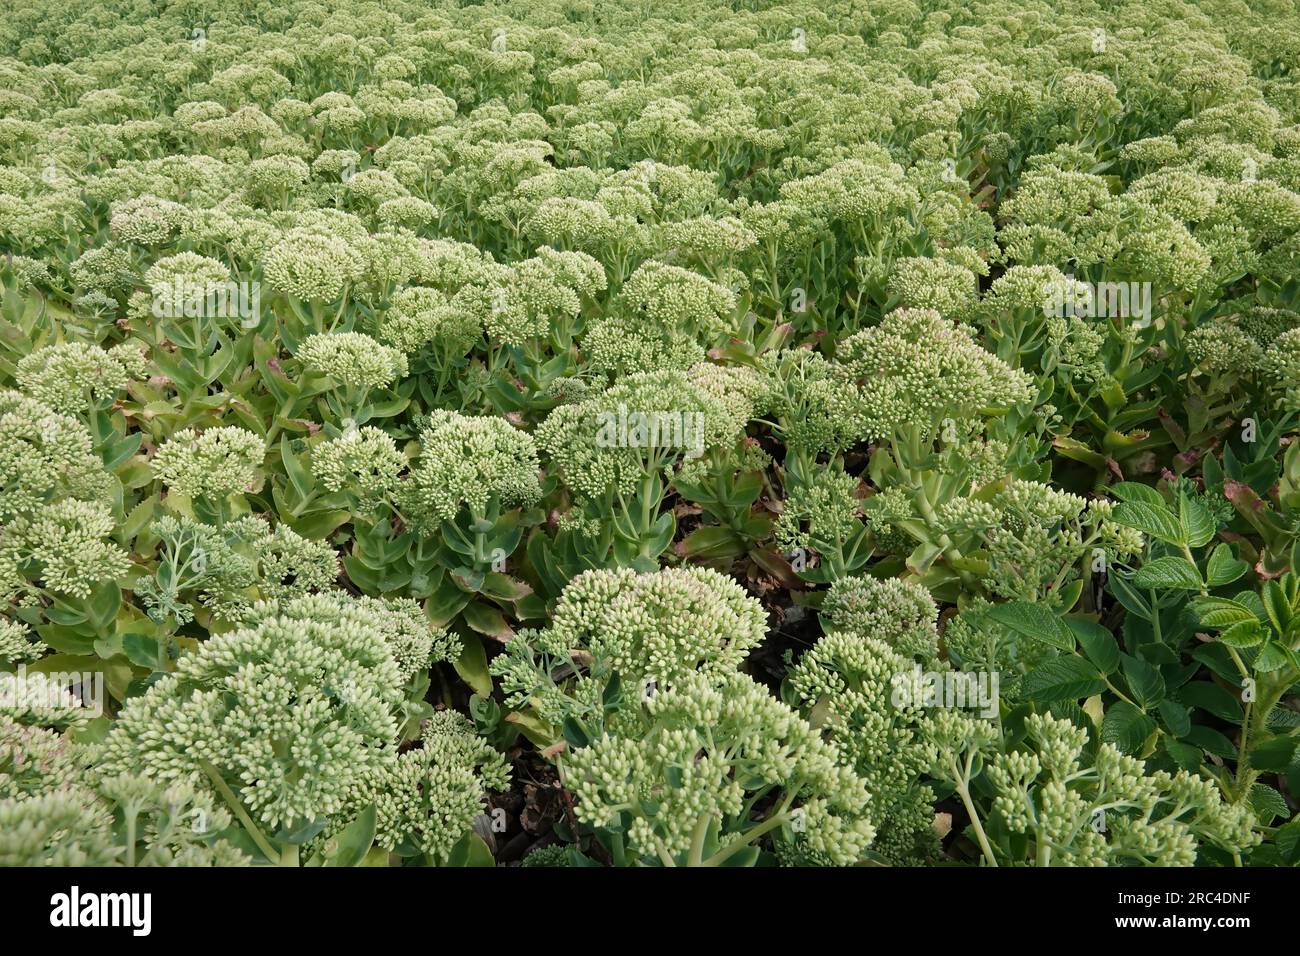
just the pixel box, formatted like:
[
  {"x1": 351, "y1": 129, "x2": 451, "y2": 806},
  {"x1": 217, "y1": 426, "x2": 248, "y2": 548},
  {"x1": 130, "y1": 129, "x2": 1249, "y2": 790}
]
[{"x1": 563, "y1": 674, "x2": 875, "y2": 866}]
